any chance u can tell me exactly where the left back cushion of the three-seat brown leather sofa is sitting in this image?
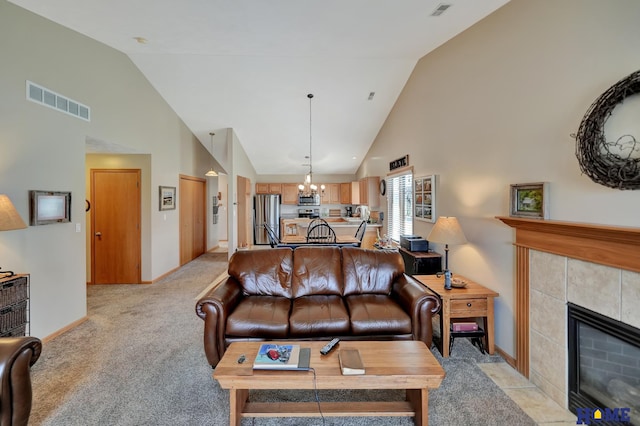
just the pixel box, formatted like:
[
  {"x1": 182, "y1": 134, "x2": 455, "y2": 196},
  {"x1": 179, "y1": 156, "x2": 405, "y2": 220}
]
[{"x1": 229, "y1": 248, "x2": 293, "y2": 298}]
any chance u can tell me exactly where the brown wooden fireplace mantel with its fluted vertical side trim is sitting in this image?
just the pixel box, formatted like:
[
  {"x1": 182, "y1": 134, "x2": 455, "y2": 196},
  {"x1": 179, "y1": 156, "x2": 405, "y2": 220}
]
[{"x1": 497, "y1": 216, "x2": 640, "y2": 377}]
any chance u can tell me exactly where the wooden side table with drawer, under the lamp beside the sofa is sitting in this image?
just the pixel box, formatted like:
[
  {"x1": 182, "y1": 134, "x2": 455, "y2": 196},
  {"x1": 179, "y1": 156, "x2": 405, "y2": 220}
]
[{"x1": 413, "y1": 274, "x2": 499, "y2": 358}]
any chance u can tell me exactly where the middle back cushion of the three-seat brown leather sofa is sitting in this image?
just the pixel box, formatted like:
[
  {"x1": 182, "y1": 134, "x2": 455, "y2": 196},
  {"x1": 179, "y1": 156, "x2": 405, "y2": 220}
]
[{"x1": 291, "y1": 246, "x2": 343, "y2": 298}]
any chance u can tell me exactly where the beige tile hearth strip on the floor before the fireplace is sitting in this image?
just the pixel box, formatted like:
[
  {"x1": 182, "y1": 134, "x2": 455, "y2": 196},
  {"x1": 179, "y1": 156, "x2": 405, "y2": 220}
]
[{"x1": 478, "y1": 362, "x2": 577, "y2": 426}]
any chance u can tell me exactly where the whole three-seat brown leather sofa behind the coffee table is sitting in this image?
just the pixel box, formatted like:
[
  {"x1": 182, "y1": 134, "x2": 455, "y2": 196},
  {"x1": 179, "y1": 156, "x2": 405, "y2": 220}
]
[{"x1": 196, "y1": 246, "x2": 440, "y2": 368}]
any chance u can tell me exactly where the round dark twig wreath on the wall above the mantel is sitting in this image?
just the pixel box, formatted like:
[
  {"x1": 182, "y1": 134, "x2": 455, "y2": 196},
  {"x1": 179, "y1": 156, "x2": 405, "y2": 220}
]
[{"x1": 572, "y1": 71, "x2": 640, "y2": 189}]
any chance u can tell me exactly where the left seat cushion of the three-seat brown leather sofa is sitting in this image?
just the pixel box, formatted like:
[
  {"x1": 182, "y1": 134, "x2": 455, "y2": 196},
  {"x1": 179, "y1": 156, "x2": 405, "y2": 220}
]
[{"x1": 226, "y1": 296, "x2": 291, "y2": 338}]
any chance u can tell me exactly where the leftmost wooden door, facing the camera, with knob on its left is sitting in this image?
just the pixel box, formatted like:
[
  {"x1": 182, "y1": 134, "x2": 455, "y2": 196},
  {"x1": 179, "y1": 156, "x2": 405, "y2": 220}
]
[{"x1": 91, "y1": 169, "x2": 142, "y2": 284}]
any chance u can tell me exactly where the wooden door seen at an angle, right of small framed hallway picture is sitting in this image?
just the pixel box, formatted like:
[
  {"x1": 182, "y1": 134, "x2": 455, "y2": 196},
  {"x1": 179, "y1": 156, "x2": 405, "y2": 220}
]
[{"x1": 178, "y1": 176, "x2": 207, "y2": 265}]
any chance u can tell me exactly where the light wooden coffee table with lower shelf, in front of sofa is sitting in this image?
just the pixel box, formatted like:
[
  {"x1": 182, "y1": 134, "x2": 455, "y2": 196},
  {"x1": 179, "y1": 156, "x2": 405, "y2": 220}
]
[{"x1": 213, "y1": 341, "x2": 445, "y2": 425}]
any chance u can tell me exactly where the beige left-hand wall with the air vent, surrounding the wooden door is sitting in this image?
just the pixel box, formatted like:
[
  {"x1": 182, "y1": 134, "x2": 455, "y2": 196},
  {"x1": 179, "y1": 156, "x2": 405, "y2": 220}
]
[{"x1": 0, "y1": 0, "x2": 222, "y2": 337}]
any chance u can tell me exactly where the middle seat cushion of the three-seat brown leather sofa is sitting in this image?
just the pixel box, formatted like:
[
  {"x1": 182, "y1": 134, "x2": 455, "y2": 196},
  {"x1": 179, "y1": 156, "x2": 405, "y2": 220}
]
[{"x1": 289, "y1": 295, "x2": 350, "y2": 337}]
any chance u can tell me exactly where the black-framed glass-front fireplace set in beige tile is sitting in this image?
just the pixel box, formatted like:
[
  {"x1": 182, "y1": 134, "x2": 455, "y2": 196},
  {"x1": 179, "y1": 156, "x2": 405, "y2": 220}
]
[{"x1": 568, "y1": 303, "x2": 640, "y2": 426}]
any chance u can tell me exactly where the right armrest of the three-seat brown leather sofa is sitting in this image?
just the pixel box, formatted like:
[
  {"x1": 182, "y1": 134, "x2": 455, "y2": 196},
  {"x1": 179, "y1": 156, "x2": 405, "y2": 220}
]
[{"x1": 391, "y1": 274, "x2": 440, "y2": 348}]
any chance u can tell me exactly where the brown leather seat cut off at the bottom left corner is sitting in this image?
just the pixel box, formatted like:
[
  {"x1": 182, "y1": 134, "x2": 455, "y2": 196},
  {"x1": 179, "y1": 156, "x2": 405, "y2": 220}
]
[{"x1": 0, "y1": 337, "x2": 42, "y2": 426}]
